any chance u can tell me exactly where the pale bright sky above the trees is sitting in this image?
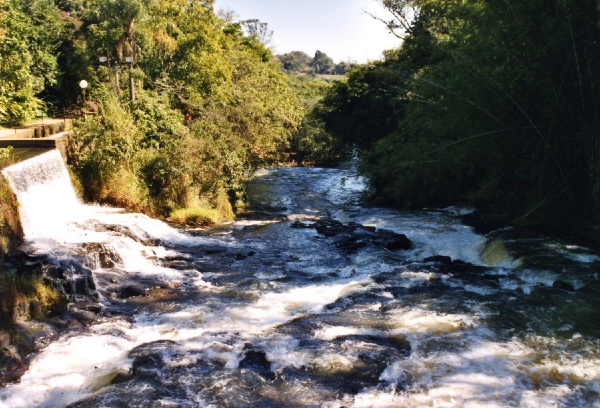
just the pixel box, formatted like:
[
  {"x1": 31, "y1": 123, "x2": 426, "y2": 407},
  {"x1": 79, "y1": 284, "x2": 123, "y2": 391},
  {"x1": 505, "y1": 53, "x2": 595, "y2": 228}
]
[{"x1": 214, "y1": 0, "x2": 400, "y2": 63}]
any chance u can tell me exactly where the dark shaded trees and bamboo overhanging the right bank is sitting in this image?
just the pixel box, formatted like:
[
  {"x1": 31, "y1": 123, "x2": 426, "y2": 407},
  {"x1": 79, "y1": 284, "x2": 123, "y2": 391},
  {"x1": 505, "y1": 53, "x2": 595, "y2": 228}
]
[{"x1": 316, "y1": 0, "x2": 600, "y2": 230}]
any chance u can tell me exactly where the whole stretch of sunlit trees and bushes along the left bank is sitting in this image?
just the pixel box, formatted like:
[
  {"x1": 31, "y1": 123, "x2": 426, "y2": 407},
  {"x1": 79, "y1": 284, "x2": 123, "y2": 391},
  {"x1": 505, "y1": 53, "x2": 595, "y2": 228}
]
[{"x1": 0, "y1": 0, "x2": 342, "y2": 224}]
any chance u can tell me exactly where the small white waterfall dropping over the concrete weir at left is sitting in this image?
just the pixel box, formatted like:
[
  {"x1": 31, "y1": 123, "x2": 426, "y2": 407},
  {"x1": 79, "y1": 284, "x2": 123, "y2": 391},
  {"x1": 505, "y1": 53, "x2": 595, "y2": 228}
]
[{"x1": 2, "y1": 150, "x2": 84, "y2": 241}]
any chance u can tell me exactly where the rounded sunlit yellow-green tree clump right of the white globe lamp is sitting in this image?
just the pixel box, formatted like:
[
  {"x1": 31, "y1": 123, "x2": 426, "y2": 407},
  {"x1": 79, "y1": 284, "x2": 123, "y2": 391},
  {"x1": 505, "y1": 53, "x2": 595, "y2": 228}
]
[{"x1": 62, "y1": 0, "x2": 303, "y2": 224}]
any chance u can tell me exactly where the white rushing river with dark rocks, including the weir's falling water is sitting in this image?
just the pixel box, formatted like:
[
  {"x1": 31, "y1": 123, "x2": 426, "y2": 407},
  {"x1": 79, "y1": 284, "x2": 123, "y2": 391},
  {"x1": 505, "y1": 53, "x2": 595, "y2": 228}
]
[{"x1": 0, "y1": 152, "x2": 600, "y2": 408}]
